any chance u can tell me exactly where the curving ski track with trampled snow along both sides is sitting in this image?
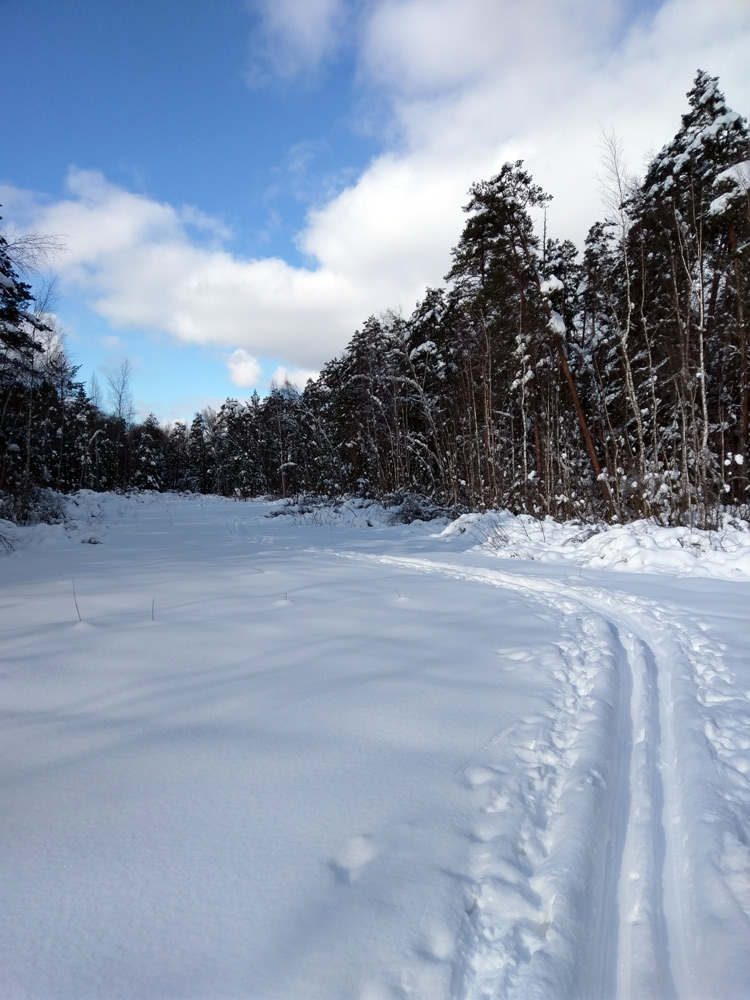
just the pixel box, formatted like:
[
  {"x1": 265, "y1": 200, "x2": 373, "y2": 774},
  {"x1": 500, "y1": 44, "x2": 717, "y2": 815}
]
[{"x1": 339, "y1": 552, "x2": 750, "y2": 1000}]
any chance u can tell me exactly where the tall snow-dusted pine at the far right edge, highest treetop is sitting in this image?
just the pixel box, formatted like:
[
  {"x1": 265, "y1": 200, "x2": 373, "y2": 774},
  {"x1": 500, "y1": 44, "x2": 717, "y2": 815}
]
[{"x1": 633, "y1": 71, "x2": 750, "y2": 521}]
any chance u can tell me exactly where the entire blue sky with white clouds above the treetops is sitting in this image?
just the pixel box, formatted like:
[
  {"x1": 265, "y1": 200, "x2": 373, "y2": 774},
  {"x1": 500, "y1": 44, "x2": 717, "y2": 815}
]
[{"x1": 0, "y1": 0, "x2": 750, "y2": 421}]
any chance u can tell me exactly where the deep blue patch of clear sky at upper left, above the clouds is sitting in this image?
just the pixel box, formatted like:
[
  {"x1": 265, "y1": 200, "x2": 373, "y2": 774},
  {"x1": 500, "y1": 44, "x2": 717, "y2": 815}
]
[{"x1": 0, "y1": 0, "x2": 378, "y2": 255}]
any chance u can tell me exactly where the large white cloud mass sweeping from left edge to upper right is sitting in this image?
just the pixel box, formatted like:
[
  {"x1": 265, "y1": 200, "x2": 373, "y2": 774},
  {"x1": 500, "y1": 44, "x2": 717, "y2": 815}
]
[{"x1": 0, "y1": 0, "x2": 750, "y2": 384}]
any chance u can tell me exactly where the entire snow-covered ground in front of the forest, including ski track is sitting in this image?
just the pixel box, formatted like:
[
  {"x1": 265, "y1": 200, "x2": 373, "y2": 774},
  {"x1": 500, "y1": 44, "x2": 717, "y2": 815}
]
[{"x1": 0, "y1": 493, "x2": 750, "y2": 1000}]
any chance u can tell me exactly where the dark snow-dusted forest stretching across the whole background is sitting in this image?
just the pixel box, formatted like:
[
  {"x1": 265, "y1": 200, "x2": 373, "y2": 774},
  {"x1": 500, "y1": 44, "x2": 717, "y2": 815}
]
[{"x1": 0, "y1": 71, "x2": 750, "y2": 527}]
